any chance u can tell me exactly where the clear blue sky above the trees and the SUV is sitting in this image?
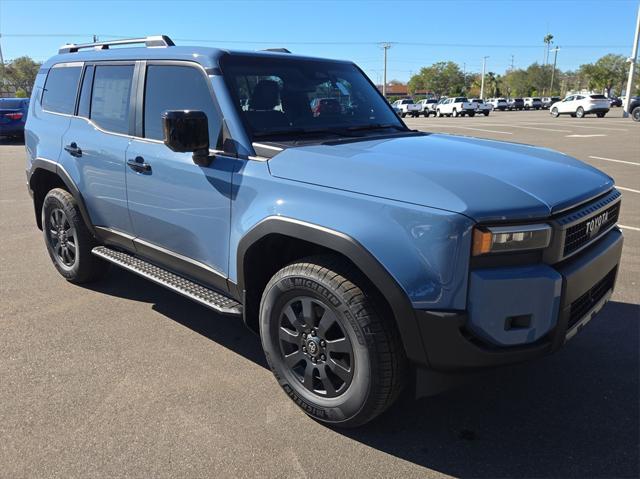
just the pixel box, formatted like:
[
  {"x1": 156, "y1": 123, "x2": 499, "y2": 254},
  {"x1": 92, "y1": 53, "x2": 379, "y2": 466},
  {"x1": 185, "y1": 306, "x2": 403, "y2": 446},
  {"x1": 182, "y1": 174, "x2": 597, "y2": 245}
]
[{"x1": 0, "y1": 0, "x2": 639, "y2": 83}]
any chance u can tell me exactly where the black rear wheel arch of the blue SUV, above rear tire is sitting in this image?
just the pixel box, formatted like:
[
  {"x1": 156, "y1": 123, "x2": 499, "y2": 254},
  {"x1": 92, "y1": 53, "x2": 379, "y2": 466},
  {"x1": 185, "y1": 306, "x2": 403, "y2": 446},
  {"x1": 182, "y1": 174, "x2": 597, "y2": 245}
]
[{"x1": 28, "y1": 158, "x2": 95, "y2": 236}]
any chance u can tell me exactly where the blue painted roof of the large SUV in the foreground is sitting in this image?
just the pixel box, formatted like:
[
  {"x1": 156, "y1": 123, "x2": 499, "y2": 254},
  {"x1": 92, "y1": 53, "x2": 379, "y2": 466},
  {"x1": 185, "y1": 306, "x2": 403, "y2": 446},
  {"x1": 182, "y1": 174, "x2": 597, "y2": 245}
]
[{"x1": 42, "y1": 37, "x2": 352, "y2": 73}]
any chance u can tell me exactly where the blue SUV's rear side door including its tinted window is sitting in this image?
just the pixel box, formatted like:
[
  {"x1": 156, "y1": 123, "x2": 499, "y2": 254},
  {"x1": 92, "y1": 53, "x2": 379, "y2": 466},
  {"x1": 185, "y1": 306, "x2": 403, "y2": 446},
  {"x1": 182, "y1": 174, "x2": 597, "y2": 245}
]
[{"x1": 60, "y1": 62, "x2": 135, "y2": 235}]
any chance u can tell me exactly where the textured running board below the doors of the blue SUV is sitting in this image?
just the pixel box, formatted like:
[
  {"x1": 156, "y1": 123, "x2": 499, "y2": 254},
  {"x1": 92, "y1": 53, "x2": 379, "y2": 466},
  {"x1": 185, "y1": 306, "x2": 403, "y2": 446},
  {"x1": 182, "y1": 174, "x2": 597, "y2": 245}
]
[{"x1": 91, "y1": 246, "x2": 242, "y2": 315}]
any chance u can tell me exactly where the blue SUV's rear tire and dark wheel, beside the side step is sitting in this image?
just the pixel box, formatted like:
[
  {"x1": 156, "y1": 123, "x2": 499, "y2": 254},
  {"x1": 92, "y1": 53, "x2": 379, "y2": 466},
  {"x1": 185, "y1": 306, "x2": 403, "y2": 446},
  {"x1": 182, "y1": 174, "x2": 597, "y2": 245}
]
[{"x1": 42, "y1": 188, "x2": 109, "y2": 284}]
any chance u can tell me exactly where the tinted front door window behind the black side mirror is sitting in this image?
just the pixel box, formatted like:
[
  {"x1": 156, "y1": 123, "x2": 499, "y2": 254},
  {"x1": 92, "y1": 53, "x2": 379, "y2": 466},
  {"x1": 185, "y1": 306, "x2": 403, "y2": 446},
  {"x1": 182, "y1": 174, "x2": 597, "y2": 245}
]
[{"x1": 144, "y1": 65, "x2": 221, "y2": 145}]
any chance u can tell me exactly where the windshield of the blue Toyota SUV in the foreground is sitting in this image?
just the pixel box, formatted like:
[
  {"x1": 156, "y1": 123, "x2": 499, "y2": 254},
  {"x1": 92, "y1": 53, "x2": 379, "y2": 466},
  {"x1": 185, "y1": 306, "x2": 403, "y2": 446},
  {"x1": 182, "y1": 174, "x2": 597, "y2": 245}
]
[{"x1": 221, "y1": 56, "x2": 402, "y2": 137}]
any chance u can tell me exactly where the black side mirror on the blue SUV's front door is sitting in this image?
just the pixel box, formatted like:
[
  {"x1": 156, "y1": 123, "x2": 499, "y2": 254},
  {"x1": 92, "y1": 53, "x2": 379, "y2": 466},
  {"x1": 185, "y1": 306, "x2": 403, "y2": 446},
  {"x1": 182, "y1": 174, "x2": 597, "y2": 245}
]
[{"x1": 162, "y1": 110, "x2": 211, "y2": 166}]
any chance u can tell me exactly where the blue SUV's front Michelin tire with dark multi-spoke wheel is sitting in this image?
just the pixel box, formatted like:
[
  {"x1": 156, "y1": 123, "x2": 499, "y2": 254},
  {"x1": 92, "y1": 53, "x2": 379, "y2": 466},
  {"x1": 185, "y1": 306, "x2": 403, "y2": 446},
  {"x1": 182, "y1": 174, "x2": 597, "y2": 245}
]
[{"x1": 260, "y1": 256, "x2": 407, "y2": 427}]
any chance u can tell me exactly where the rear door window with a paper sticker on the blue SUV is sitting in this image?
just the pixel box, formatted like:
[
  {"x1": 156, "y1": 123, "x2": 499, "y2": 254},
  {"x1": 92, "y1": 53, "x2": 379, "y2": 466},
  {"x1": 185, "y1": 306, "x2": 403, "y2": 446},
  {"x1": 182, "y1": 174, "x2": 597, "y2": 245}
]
[{"x1": 90, "y1": 65, "x2": 133, "y2": 133}]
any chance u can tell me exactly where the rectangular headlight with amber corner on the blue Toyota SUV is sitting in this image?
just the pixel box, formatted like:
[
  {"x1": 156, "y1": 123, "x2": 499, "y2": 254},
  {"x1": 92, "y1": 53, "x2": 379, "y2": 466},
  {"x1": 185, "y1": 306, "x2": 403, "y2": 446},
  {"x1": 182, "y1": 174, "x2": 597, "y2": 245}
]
[{"x1": 473, "y1": 224, "x2": 551, "y2": 256}]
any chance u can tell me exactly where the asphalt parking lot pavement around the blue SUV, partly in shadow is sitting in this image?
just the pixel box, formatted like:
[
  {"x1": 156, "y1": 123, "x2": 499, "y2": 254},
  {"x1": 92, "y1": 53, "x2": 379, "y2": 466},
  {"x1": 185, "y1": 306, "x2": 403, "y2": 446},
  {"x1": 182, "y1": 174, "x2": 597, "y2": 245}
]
[{"x1": 0, "y1": 109, "x2": 640, "y2": 478}]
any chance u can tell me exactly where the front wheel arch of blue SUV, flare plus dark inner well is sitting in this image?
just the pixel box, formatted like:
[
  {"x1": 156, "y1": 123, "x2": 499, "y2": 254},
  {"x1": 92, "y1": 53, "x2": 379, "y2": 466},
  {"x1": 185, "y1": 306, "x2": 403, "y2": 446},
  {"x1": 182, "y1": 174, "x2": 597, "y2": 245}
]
[{"x1": 237, "y1": 216, "x2": 428, "y2": 365}]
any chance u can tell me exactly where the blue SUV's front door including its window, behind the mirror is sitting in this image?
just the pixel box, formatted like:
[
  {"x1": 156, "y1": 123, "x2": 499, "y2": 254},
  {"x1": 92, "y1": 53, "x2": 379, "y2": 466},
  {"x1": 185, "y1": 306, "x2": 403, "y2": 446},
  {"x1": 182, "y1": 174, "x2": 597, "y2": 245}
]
[{"x1": 126, "y1": 62, "x2": 236, "y2": 279}]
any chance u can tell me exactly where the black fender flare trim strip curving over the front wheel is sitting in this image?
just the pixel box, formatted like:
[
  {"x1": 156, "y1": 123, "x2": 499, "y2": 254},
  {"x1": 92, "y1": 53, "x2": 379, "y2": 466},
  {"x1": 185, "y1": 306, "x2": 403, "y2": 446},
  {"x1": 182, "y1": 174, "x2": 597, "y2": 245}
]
[{"x1": 237, "y1": 216, "x2": 428, "y2": 365}]
